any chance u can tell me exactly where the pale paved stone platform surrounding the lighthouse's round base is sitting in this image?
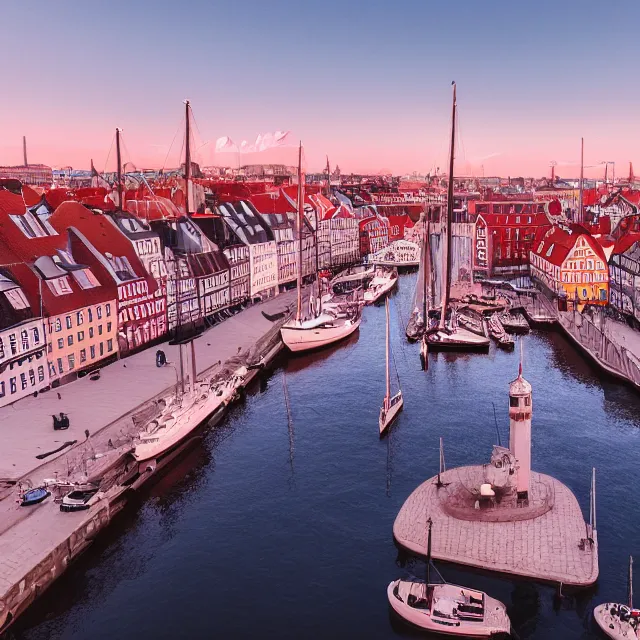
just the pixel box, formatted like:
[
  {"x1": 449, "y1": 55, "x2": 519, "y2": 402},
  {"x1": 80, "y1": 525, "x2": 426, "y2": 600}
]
[{"x1": 393, "y1": 465, "x2": 598, "y2": 587}]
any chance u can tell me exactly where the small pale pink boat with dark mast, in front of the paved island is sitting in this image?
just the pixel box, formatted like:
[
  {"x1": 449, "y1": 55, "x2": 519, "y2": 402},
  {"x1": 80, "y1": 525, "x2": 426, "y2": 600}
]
[{"x1": 387, "y1": 518, "x2": 511, "y2": 638}]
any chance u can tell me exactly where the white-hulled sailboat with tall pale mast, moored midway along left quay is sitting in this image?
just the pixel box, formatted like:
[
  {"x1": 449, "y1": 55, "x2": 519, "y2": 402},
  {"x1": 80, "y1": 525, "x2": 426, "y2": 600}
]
[{"x1": 280, "y1": 143, "x2": 362, "y2": 352}]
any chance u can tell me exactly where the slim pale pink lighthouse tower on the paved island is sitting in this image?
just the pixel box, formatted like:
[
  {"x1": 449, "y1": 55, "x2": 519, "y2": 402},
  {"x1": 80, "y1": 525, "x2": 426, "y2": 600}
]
[{"x1": 509, "y1": 357, "x2": 532, "y2": 498}]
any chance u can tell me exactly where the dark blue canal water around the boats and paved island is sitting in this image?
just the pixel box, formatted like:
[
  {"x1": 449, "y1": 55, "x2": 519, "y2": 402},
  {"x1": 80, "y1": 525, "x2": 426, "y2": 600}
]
[{"x1": 9, "y1": 275, "x2": 640, "y2": 640}]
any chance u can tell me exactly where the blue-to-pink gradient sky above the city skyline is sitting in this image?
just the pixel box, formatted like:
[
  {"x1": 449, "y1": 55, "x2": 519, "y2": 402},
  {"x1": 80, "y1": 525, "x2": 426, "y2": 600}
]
[{"x1": 0, "y1": 0, "x2": 640, "y2": 177}]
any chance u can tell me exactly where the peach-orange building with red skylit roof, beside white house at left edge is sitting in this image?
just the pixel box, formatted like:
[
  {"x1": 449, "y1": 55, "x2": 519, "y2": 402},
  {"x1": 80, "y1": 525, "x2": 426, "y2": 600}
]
[{"x1": 0, "y1": 191, "x2": 118, "y2": 383}]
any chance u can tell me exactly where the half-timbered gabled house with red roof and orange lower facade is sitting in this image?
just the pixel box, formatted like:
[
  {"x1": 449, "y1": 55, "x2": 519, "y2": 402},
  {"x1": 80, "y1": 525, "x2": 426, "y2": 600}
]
[{"x1": 530, "y1": 224, "x2": 609, "y2": 310}]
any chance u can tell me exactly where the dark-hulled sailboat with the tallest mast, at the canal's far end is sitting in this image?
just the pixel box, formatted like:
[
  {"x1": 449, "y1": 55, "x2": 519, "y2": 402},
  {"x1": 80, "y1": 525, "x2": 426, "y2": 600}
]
[{"x1": 426, "y1": 82, "x2": 489, "y2": 351}]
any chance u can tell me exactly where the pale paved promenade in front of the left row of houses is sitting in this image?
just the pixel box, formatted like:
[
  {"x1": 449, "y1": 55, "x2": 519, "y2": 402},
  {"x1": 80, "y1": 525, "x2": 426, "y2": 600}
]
[{"x1": 0, "y1": 291, "x2": 295, "y2": 484}]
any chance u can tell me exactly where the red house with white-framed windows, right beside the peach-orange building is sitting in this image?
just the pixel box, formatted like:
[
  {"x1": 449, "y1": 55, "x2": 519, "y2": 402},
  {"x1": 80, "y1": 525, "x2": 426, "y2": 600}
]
[{"x1": 49, "y1": 202, "x2": 162, "y2": 355}]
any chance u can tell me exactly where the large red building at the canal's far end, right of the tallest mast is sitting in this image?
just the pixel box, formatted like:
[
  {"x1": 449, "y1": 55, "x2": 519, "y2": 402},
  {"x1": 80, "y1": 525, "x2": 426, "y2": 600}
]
[{"x1": 473, "y1": 201, "x2": 551, "y2": 277}]
